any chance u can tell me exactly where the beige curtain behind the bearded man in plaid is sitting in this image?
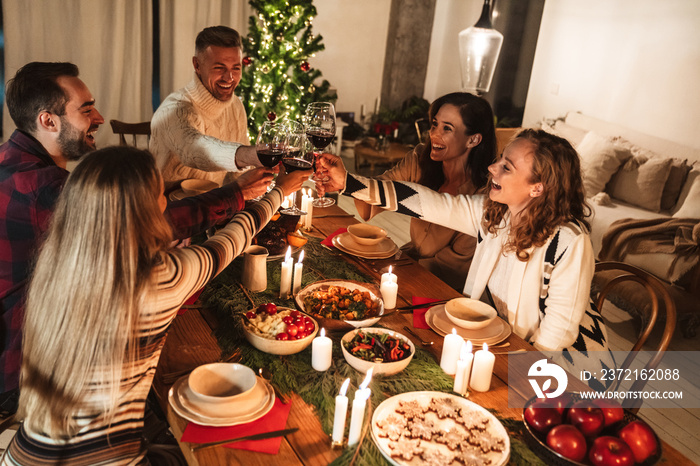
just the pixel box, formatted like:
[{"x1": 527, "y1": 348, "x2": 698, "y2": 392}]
[{"x1": 2, "y1": 0, "x2": 153, "y2": 147}]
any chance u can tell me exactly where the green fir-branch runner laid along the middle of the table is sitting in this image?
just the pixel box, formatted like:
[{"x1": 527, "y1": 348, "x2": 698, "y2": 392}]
[{"x1": 200, "y1": 238, "x2": 538, "y2": 465}]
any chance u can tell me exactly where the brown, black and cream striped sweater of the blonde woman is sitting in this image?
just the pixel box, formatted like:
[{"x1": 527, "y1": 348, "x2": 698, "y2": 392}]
[{"x1": 0, "y1": 188, "x2": 283, "y2": 465}]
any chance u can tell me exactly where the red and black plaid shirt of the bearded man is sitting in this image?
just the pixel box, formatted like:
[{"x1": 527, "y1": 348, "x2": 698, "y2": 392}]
[{"x1": 0, "y1": 131, "x2": 245, "y2": 393}]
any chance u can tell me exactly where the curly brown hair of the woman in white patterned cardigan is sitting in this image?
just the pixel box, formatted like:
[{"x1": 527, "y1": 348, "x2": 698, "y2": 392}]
[{"x1": 483, "y1": 129, "x2": 591, "y2": 261}]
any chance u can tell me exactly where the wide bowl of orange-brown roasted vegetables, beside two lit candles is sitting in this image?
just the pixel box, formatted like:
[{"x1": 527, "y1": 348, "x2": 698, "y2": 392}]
[{"x1": 295, "y1": 280, "x2": 384, "y2": 328}]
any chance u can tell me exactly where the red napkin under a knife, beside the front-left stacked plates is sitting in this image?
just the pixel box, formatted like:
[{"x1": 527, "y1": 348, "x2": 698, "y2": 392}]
[{"x1": 180, "y1": 398, "x2": 292, "y2": 455}]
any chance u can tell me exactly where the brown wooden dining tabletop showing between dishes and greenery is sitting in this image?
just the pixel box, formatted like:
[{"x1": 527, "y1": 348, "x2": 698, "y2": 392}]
[{"x1": 153, "y1": 205, "x2": 693, "y2": 466}]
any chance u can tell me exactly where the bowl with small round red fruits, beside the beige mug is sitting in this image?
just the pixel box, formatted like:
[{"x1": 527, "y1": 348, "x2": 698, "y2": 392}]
[{"x1": 243, "y1": 303, "x2": 318, "y2": 355}]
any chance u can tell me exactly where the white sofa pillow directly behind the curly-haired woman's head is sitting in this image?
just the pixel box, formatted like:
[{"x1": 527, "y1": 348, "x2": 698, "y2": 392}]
[{"x1": 576, "y1": 131, "x2": 632, "y2": 197}]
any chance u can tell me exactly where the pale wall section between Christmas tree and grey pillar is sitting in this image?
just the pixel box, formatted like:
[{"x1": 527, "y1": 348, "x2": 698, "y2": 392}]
[{"x1": 309, "y1": 0, "x2": 391, "y2": 121}]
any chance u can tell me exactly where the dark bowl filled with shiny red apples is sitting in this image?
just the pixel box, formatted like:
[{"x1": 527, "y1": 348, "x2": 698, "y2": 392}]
[{"x1": 523, "y1": 393, "x2": 661, "y2": 466}]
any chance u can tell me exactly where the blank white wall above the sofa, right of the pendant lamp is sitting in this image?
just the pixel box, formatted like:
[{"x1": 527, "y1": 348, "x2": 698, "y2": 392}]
[{"x1": 523, "y1": 0, "x2": 700, "y2": 148}]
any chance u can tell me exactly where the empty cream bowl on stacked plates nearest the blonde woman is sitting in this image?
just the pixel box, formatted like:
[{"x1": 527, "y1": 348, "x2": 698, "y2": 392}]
[{"x1": 187, "y1": 362, "x2": 257, "y2": 403}]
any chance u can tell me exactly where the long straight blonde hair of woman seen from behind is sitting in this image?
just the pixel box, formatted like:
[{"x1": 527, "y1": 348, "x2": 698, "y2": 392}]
[{"x1": 19, "y1": 147, "x2": 172, "y2": 438}]
